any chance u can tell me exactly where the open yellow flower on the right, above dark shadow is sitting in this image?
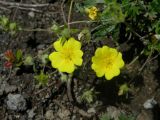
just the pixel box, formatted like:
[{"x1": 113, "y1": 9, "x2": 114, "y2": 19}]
[{"x1": 91, "y1": 46, "x2": 124, "y2": 80}]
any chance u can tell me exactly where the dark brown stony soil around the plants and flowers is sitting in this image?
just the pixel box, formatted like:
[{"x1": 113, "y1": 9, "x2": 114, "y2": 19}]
[{"x1": 0, "y1": 0, "x2": 160, "y2": 120}]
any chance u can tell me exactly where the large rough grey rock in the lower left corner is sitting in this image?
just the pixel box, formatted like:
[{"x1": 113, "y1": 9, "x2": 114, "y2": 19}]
[{"x1": 7, "y1": 94, "x2": 26, "y2": 111}]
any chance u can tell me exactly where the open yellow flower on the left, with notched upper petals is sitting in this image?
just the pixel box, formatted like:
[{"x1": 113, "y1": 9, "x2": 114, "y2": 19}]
[{"x1": 49, "y1": 37, "x2": 83, "y2": 73}]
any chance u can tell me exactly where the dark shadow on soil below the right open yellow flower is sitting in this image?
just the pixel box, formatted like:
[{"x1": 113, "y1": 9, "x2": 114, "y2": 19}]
[{"x1": 96, "y1": 75, "x2": 143, "y2": 106}]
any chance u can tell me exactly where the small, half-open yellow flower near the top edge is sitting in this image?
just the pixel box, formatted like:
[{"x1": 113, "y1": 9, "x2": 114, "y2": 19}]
[{"x1": 86, "y1": 6, "x2": 98, "y2": 20}]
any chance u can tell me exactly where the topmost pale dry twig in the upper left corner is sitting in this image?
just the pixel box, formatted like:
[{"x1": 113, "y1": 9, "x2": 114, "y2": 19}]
[{"x1": 0, "y1": 1, "x2": 49, "y2": 7}]
